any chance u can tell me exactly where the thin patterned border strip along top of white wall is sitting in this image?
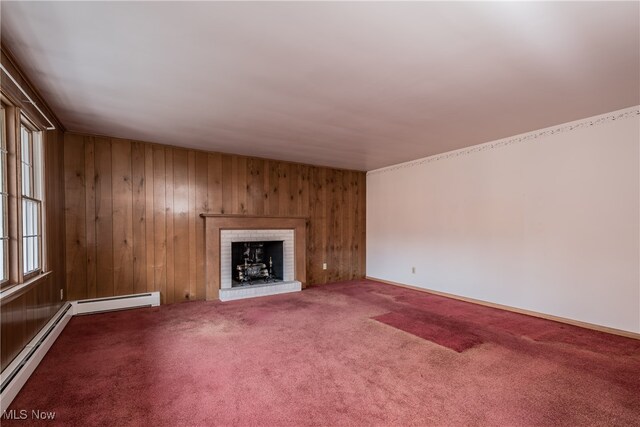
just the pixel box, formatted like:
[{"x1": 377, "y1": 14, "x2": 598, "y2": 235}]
[{"x1": 367, "y1": 105, "x2": 640, "y2": 176}]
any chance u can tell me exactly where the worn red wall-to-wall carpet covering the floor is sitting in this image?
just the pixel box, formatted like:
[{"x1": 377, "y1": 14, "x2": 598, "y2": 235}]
[{"x1": 2, "y1": 281, "x2": 640, "y2": 426}]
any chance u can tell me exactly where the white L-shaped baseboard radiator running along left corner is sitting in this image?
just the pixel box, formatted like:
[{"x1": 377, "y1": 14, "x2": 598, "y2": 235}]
[{"x1": 0, "y1": 292, "x2": 160, "y2": 414}]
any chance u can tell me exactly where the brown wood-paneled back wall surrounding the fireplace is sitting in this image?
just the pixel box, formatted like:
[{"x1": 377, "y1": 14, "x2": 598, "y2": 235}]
[{"x1": 64, "y1": 133, "x2": 366, "y2": 303}]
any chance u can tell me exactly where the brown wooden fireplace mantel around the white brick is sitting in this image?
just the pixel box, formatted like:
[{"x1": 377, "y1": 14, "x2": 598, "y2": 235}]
[{"x1": 200, "y1": 213, "x2": 309, "y2": 300}]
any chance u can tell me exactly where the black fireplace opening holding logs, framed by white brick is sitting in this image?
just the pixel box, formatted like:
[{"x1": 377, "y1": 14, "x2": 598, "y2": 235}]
[{"x1": 231, "y1": 240, "x2": 284, "y2": 287}]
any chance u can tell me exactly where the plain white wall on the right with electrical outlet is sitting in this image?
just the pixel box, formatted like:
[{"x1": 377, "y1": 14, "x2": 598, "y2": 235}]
[{"x1": 367, "y1": 107, "x2": 640, "y2": 332}]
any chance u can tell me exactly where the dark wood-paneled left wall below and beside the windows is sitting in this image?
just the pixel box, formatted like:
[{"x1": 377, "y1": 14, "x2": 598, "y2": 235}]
[{"x1": 0, "y1": 131, "x2": 65, "y2": 370}]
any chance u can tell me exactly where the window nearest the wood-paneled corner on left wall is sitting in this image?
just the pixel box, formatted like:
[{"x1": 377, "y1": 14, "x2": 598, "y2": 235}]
[{"x1": 20, "y1": 119, "x2": 42, "y2": 276}]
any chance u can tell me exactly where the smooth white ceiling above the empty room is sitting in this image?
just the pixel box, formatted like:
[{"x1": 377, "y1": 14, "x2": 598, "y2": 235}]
[{"x1": 1, "y1": 1, "x2": 640, "y2": 170}]
